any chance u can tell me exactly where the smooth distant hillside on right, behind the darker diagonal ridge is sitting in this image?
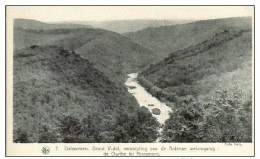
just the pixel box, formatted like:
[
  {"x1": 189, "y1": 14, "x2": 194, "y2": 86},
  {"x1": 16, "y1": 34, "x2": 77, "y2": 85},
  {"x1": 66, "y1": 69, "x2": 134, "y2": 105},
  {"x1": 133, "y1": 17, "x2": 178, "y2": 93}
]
[{"x1": 125, "y1": 17, "x2": 252, "y2": 58}]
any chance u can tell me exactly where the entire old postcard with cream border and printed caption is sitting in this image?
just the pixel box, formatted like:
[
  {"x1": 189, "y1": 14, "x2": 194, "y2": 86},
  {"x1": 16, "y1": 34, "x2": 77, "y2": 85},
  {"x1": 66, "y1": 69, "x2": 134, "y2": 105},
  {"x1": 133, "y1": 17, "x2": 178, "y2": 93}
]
[{"x1": 6, "y1": 6, "x2": 254, "y2": 156}]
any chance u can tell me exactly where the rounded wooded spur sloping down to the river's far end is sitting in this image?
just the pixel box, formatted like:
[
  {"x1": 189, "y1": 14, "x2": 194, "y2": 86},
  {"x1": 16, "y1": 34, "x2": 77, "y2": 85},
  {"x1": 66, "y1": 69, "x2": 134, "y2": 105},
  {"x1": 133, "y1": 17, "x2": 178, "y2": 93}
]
[{"x1": 51, "y1": 29, "x2": 158, "y2": 82}]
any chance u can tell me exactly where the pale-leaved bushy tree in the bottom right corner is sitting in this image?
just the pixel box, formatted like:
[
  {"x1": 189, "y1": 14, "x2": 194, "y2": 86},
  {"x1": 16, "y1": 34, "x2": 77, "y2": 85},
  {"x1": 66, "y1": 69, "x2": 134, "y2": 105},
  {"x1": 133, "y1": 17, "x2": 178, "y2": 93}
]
[{"x1": 204, "y1": 90, "x2": 252, "y2": 142}]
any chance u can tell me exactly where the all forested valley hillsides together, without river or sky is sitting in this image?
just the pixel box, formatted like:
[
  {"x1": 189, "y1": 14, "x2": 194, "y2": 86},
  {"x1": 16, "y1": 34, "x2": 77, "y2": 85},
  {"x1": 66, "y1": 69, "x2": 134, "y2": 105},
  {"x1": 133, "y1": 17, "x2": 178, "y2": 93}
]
[{"x1": 13, "y1": 17, "x2": 254, "y2": 143}]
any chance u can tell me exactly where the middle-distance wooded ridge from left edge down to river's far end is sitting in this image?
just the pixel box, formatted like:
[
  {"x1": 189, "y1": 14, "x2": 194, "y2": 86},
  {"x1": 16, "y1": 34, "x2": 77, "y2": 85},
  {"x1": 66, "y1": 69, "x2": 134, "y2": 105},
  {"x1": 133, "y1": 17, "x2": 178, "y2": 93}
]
[{"x1": 14, "y1": 25, "x2": 158, "y2": 82}]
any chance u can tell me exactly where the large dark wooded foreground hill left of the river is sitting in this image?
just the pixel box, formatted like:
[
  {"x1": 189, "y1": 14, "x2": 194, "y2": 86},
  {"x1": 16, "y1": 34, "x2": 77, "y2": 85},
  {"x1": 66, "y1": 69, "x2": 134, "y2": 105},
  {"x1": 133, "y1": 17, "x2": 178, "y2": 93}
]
[{"x1": 13, "y1": 46, "x2": 158, "y2": 143}]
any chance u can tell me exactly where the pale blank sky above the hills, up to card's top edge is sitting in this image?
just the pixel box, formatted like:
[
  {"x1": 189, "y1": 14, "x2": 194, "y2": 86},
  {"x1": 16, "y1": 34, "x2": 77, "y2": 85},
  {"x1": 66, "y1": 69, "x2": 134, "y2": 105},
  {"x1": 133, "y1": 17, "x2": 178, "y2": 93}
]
[{"x1": 7, "y1": 6, "x2": 254, "y2": 22}]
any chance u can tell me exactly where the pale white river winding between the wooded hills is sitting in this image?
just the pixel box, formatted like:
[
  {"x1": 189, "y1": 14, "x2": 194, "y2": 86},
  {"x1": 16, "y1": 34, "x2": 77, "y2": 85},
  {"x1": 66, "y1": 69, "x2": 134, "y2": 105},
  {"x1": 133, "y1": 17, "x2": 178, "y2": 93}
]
[{"x1": 125, "y1": 73, "x2": 172, "y2": 142}]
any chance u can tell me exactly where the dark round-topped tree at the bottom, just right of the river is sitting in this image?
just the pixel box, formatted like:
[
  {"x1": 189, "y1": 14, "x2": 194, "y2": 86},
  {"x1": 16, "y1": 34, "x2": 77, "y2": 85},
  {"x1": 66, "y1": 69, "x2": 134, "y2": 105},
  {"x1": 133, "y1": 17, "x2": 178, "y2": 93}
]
[{"x1": 162, "y1": 97, "x2": 204, "y2": 142}]
